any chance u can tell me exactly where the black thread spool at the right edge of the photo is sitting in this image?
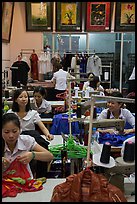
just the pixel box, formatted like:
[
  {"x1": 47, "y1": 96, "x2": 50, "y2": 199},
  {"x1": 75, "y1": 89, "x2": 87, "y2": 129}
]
[{"x1": 123, "y1": 141, "x2": 135, "y2": 162}]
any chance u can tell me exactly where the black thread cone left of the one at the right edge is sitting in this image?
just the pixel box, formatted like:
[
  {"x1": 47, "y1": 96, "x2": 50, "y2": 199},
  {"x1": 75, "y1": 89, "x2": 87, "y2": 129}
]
[{"x1": 100, "y1": 142, "x2": 111, "y2": 164}]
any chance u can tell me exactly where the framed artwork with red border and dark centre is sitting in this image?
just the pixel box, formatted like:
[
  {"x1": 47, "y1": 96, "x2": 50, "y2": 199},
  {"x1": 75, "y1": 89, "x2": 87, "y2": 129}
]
[{"x1": 86, "y1": 2, "x2": 111, "y2": 31}]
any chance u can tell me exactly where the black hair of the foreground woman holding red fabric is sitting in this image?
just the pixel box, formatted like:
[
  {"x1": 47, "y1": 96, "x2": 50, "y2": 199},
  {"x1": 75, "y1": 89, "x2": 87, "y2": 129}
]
[{"x1": 2, "y1": 113, "x2": 20, "y2": 156}]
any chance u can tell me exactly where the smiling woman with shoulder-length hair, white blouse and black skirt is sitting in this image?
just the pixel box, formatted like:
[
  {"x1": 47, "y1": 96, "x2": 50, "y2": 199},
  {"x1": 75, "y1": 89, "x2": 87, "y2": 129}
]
[{"x1": 8, "y1": 89, "x2": 53, "y2": 177}]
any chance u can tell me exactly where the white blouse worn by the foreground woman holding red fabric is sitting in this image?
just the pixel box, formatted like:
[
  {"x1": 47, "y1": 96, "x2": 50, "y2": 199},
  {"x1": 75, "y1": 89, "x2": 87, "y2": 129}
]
[{"x1": 4, "y1": 135, "x2": 37, "y2": 178}]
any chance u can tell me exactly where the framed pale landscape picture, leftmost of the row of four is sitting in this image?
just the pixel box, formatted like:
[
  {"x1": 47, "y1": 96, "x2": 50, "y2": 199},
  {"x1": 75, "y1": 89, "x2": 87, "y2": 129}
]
[{"x1": 26, "y1": 2, "x2": 53, "y2": 31}]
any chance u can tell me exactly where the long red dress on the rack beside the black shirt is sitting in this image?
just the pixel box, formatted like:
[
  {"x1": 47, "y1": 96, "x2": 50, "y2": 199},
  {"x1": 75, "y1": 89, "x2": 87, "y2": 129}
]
[{"x1": 30, "y1": 49, "x2": 38, "y2": 80}]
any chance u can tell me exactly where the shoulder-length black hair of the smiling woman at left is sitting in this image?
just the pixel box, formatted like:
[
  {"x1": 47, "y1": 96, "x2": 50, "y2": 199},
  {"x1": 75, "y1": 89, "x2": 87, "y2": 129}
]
[{"x1": 12, "y1": 88, "x2": 31, "y2": 112}]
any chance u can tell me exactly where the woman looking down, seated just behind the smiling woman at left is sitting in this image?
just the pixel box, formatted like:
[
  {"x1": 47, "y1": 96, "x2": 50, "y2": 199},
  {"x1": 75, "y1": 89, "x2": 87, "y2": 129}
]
[{"x1": 32, "y1": 86, "x2": 53, "y2": 118}]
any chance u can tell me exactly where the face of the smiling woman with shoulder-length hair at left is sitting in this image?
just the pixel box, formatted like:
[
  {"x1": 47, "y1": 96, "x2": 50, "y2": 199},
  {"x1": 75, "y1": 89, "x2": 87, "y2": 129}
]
[{"x1": 16, "y1": 91, "x2": 28, "y2": 107}]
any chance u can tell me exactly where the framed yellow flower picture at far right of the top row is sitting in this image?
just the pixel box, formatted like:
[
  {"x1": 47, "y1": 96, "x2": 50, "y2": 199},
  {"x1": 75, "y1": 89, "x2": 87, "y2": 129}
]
[{"x1": 115, "y1": 2, "x2": 135, "y2": 32}]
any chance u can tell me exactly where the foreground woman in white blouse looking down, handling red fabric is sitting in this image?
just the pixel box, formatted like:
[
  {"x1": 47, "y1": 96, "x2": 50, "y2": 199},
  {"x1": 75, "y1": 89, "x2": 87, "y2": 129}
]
[{"x1": 2, "y1": 113, "x2": 53, "y2": 178}]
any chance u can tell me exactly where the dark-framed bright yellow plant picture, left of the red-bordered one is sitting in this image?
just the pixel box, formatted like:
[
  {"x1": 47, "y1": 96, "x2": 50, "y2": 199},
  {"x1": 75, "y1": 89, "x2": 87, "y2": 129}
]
[{"x1": 56, "y1": 2, "x2": 82, "y2": 32}]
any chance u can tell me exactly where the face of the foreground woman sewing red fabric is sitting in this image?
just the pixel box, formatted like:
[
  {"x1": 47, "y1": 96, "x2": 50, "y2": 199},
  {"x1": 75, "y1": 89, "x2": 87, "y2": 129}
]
[{"x1": 2, "y1": 121, "x2": 20, "y2": 145}]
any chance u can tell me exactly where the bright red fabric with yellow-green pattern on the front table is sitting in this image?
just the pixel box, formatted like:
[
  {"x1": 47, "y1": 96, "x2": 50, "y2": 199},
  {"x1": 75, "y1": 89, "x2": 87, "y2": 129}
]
[{"x1": 2, "y1": 159, "x2": 46, "y2": 198}]
